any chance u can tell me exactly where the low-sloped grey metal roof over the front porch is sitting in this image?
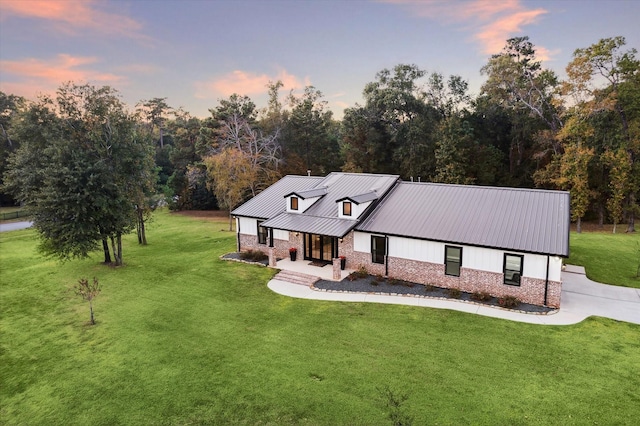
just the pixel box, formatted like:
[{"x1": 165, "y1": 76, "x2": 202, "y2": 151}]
[{"x1": 262, "y1": 213, "x2": 357, "y2": 237}]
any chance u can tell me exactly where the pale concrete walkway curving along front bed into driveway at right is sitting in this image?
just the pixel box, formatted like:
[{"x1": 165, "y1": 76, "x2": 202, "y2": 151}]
[{"x1": 268, "y1": 265, "x2": 640, "y2": 325}]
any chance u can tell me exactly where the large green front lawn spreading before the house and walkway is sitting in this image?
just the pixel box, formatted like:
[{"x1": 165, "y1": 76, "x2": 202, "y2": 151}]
[{"x1": 0, "y1": 212, "x2": 640, "y2": 425}]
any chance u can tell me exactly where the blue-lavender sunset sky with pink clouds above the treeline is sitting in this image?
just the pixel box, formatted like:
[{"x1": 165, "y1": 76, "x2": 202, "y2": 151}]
[{"x1": 0, "y1": 0, "x2": 640, "y2": 119}]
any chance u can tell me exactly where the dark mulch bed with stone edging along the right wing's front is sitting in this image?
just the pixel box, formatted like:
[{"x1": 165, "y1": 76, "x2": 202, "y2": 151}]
[{"x1": 313, "y1": 274, "x2": 557, "y2": 315}]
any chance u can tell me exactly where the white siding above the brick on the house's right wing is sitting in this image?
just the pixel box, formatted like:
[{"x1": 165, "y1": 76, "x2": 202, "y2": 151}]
[{"x1": 353, "y1": 232, "x2": 562, "y2": 281}]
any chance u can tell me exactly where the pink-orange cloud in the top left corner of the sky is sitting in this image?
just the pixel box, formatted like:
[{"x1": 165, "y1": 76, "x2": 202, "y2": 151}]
[{"x1": 0, "y1": 0, "x2": 149, "y2": 40}]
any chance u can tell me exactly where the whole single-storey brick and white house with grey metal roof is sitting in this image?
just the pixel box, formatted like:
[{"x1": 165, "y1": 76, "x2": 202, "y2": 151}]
[{"x1": 232, "y1": 173, "x2": 570, "y2": 307}]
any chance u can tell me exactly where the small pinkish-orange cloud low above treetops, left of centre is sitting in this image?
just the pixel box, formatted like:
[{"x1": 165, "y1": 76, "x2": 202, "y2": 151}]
[{"x1": 195, "y1": 70, "x2": 310, "y2": 99}]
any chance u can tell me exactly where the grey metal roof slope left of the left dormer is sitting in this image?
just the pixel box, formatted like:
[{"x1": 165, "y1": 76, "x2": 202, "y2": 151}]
[{"x1": 231, "y1": 175, "x2": 326, "y2": 219}]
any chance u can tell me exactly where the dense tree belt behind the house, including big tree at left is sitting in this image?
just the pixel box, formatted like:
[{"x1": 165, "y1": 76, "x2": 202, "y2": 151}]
[{"x1": 0, "y1": 37, "x2": 640, "y2": 262}]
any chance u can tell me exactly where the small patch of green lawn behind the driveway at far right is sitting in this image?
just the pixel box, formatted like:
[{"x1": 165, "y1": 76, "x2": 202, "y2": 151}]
[{"x1": 565, "y1": 232, "x2": 640, "y2": 288}]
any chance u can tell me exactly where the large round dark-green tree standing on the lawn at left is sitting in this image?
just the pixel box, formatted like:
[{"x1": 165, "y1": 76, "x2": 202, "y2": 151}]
[{"x1": 5, "y1": 83, "x2": 154, "y2": 265}]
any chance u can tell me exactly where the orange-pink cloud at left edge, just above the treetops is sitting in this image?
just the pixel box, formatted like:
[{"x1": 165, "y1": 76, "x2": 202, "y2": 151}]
[{"x1": 0, "y1": 54, "x2": 126, "y2": 98}]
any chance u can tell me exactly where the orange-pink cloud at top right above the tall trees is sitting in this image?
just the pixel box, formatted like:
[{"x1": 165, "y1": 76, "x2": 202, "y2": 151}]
[{"x1": 380, "y1": 0, "x2": 549, "y2": 60}]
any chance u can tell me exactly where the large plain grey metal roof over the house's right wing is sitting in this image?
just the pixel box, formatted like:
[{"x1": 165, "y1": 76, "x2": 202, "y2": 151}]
[{"x1": 356, "y1": 182, "x2": 569, "y2": 256}]
